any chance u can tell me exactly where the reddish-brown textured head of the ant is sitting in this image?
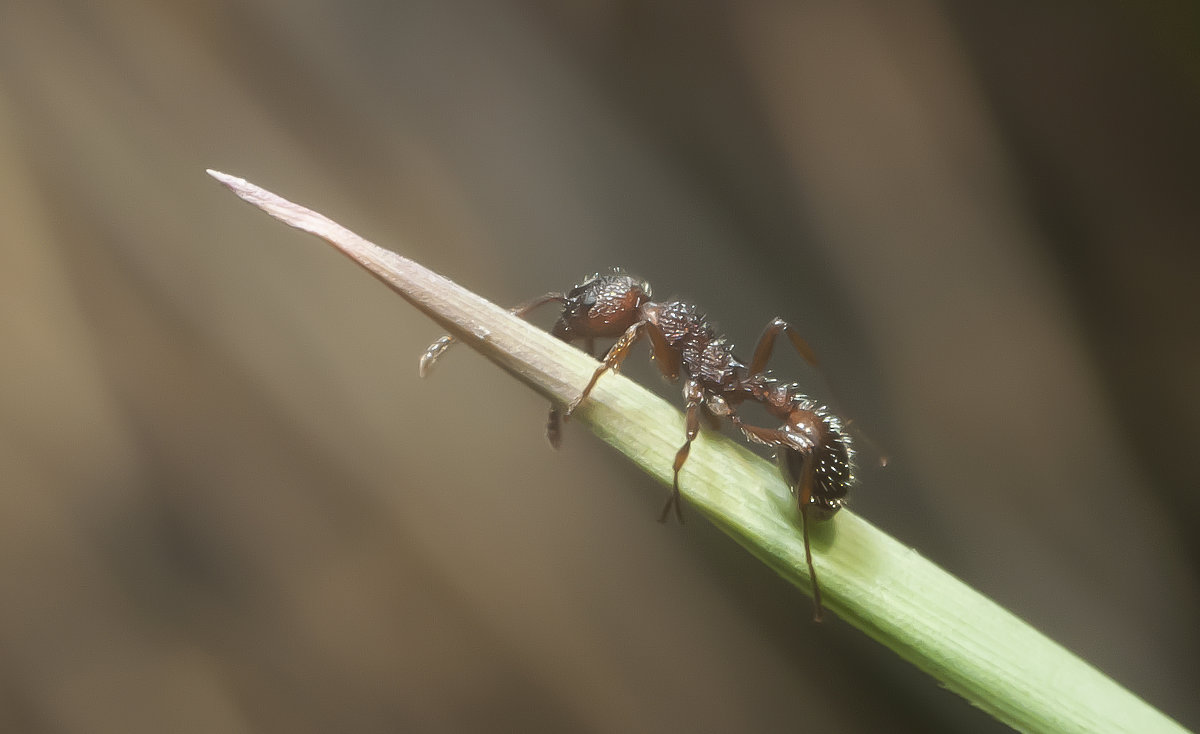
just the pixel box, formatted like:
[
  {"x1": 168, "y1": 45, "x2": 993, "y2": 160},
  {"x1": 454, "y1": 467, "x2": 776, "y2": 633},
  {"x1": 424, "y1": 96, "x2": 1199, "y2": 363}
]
[{"x1": 559, "y1": 269, "x2": 650, "y2": 338}]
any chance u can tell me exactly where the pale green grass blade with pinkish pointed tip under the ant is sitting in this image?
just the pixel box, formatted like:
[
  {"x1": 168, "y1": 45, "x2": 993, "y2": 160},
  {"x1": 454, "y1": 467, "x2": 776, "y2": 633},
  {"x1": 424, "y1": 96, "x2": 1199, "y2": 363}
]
[{"x1": 209, "y1": 170, "x2": 1184, "y2": 734}]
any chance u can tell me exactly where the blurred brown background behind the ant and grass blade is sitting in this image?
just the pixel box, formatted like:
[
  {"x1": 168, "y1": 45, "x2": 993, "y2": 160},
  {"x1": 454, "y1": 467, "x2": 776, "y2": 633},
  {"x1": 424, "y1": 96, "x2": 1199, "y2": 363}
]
[{"x1": 0, "y1": 0, "x2": 1200, "y2": 733}]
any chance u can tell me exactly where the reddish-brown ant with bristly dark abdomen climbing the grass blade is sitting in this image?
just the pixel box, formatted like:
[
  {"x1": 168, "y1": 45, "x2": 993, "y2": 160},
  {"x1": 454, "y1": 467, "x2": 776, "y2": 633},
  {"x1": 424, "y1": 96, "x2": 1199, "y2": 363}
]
[{"x1": 420, "y1": 270, "x2": 853, "y2": 621}]
